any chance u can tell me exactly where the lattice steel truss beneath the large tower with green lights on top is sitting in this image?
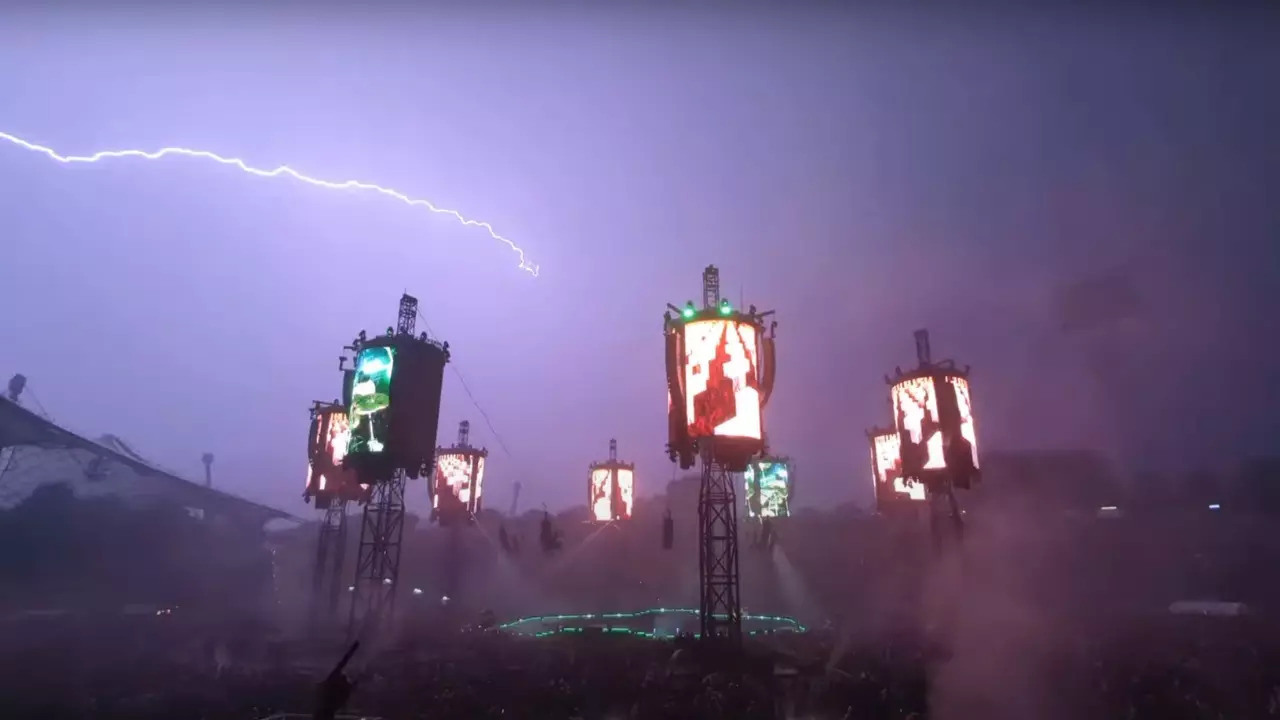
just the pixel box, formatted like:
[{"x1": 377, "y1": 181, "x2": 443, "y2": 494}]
[{"x1": 698, "y1": 443, "x2": 742, "y2": 646}]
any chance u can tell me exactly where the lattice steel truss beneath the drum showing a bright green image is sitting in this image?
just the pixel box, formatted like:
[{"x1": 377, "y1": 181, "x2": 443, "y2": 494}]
[{"x1": 347, "y1": 470, "x2": 407, "y2": 637}]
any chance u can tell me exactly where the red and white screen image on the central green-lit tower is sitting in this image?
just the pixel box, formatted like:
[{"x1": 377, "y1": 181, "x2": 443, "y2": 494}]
[{"x1": 685, "y1": 320, "x2": 760, "y2": 439}]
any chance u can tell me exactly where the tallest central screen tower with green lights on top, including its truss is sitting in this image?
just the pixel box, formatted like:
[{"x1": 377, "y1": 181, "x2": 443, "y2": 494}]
[{"x1": 663, "y1": 265, "x2": 777, "y2": 644}]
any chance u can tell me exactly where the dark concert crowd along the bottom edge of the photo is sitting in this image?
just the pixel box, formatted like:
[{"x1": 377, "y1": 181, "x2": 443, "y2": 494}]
[{"x1": 0, "y1": 614, "x2": 1280, "y2": 720}]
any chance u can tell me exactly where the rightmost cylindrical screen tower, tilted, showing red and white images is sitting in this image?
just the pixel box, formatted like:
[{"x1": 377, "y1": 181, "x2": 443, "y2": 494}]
[{"x1": 872, "y1": 329, "x2": 980, "y2": 548}]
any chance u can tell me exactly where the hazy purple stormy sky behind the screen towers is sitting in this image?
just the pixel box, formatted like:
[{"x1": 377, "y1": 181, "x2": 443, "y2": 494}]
[{"x1": 0, "y1": 4, "x2": 1280, "y2": 511}]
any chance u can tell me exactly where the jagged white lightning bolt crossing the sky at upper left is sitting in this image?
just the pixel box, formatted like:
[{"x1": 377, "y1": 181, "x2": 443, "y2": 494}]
[{"x1": 0, "y1": 131, "x2": 538, "y2": 278}]
